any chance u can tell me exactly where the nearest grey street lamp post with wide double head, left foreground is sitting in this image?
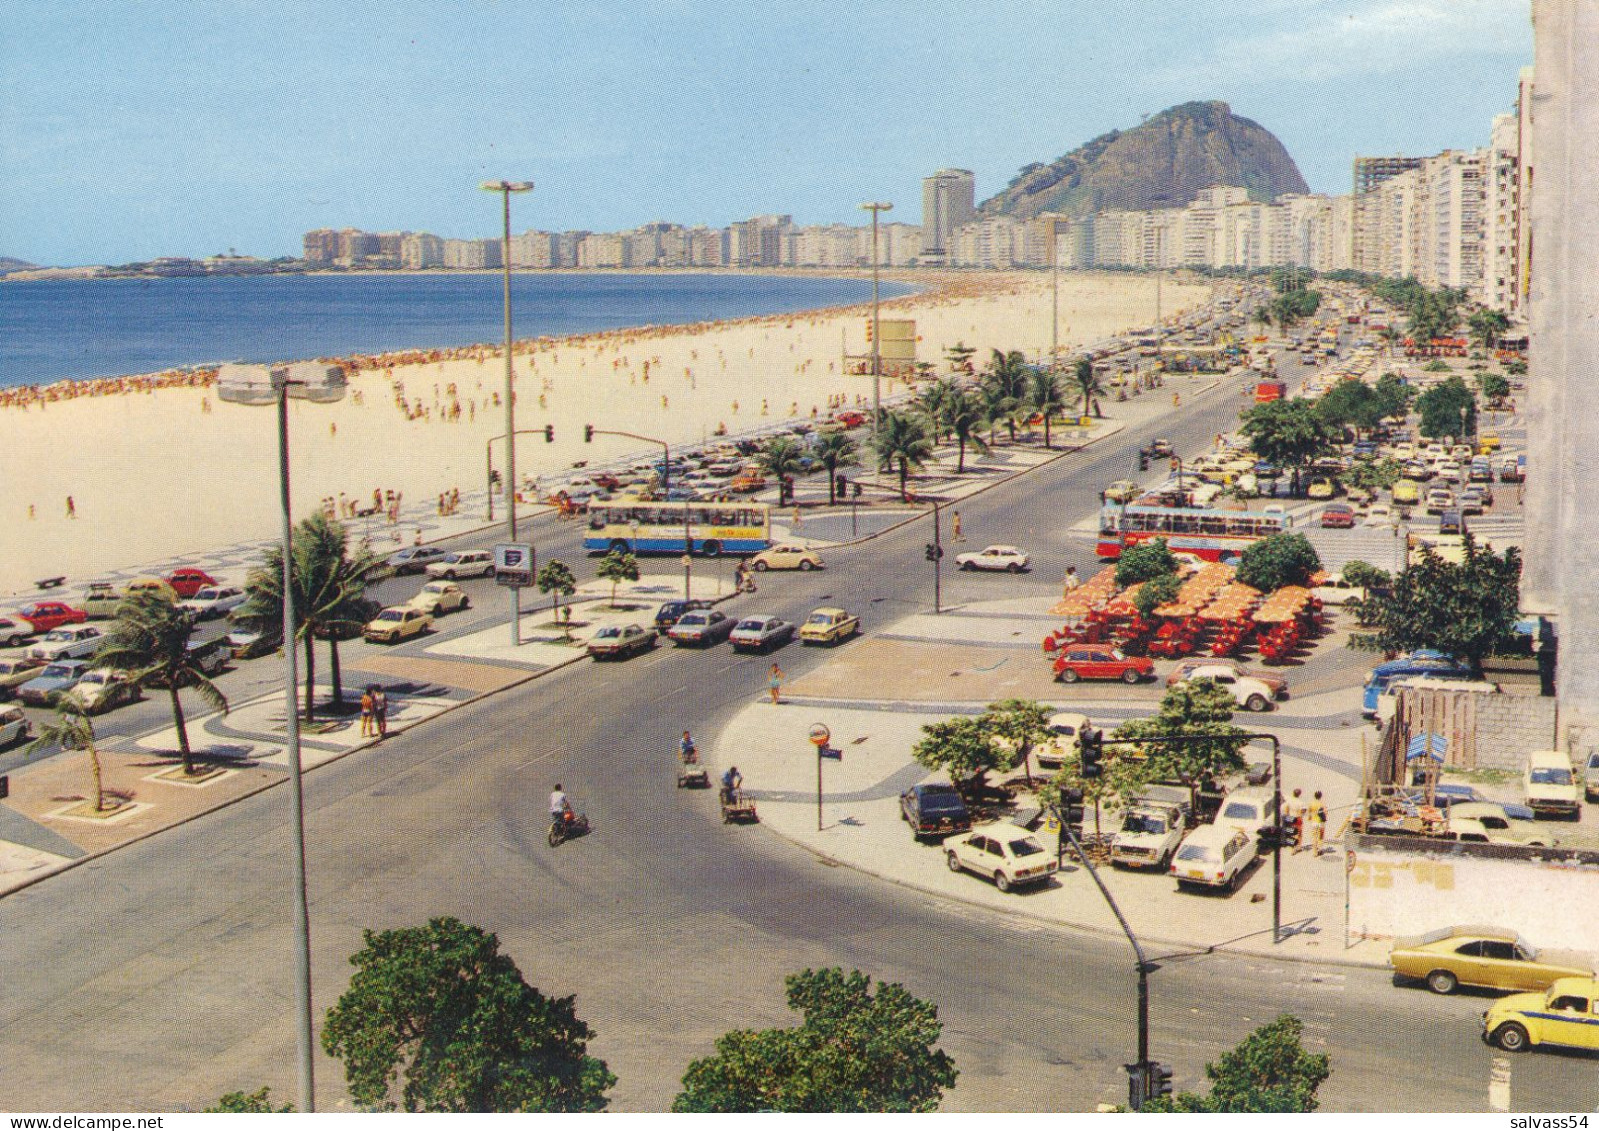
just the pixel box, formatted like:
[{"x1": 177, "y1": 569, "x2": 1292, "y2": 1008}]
[{"x1": 216, "y1": 362, "x2": 345, "y2": 1112}]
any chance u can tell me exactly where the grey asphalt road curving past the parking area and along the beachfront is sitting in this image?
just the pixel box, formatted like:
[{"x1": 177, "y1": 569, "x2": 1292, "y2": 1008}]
[{"x1": 0, "y1": 348, "x2": 1599, "y2": 1112}]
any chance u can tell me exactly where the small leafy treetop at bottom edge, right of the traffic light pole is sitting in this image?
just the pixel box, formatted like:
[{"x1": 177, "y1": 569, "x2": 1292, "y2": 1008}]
[{"x1": 1143, "y1": 1014, "x2": 1332, "y2": 1113}]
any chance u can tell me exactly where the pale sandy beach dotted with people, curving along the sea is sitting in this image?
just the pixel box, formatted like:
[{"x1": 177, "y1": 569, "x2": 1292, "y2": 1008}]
[{"x1": 0, "y1": 272, "x2": 1209, "y2": 598}]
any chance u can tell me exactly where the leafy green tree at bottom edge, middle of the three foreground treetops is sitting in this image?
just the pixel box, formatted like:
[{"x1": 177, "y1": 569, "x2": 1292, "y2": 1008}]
[{"x1": 672, "y1": 968, "x2": 958, "y2": 1112}]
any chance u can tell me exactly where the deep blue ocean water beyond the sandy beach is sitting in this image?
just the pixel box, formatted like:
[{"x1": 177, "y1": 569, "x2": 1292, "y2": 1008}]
[{"x1": 0, "y1": 274, "x2": 915, "y2": 387}]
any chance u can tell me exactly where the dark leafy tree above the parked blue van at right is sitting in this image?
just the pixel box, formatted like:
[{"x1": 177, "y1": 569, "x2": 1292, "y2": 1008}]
[{"x1": 1350, "y1": 531, "x2": 1521, "y2": 678}]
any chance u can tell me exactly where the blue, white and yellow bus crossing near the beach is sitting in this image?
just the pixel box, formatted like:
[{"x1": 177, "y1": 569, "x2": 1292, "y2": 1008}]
[{"x1": 584, "y1": 501, "x2": 772, "y2": 558}]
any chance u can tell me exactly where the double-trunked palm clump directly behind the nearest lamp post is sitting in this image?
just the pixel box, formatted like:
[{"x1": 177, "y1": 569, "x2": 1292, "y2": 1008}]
[{"x1": 240, "y1": 514, "x2": 387, "y2": 720}]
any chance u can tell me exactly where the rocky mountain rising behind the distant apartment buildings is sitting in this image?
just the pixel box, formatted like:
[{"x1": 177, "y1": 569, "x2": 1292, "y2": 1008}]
[{"x1": 979, "y1": 102, "x2": 1310, "y2": 219}]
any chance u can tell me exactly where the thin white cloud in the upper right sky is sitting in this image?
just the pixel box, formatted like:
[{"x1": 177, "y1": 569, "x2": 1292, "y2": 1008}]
[{"x1": 1154, "y1": 0, "x2": 1532, "y2": 85}]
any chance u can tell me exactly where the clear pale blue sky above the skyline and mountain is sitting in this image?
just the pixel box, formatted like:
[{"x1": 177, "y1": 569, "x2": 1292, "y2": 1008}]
[{"x1": 0, "y1": 0, "x2": 1532, "y2": 264}]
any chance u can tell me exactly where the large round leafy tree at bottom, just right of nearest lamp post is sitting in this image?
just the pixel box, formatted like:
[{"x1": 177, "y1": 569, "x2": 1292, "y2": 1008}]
[{"x1": 321, "y1": 918, "x2": 616, "y2": 1112}]
